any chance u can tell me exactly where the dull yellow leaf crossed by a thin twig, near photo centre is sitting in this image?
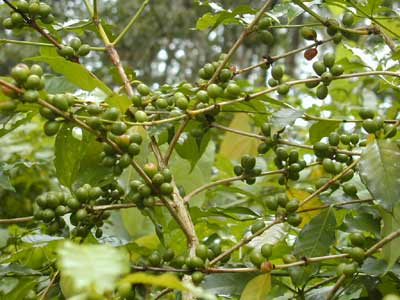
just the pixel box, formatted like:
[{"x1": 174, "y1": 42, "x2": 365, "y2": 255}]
[{"x1": 219, "y1": 113, "x2": 258, "y2": 159}]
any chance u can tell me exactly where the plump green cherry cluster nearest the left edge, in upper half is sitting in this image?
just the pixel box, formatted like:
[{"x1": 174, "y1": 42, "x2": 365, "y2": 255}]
[{"x1": 3, "y1": 64, "x2": 45, "y2": 103}]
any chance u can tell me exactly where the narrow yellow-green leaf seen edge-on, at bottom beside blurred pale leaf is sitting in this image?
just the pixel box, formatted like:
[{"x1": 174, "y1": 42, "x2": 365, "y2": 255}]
[{"x1": 123, "y1": 272, "x2": 188, "y2": 291}]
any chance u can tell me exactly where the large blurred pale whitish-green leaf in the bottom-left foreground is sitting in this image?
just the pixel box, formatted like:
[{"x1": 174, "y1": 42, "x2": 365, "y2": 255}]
[{"x1": 57, "y1": 242, "x2": 129, "y2": 294}]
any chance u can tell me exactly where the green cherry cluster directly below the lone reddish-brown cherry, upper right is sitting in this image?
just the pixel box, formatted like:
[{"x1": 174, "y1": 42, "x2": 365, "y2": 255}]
[{"x1": 306, "y1": 53, "x2": 344, "y2": 100}]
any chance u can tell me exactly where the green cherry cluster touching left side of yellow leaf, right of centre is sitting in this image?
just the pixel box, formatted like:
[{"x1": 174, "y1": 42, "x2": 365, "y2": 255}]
[{"x1": 264, "y1": 193, "x2": 302, "y2": 227}]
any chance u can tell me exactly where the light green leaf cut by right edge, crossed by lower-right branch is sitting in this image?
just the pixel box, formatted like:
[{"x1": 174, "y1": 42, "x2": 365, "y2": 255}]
[{"x1": 381, "y1": 204, "x2": 400, "y2": 271}]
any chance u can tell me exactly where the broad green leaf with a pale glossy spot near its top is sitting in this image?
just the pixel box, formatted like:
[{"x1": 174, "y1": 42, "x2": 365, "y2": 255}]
[{"x1": 54, "y1": 124, "x2": 111, "y2": 188}]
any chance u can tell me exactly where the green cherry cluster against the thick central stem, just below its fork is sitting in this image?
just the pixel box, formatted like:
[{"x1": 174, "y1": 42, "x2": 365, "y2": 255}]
[{"x1": 127, "y1": 163, "x2": 173, "y2": 208}]
